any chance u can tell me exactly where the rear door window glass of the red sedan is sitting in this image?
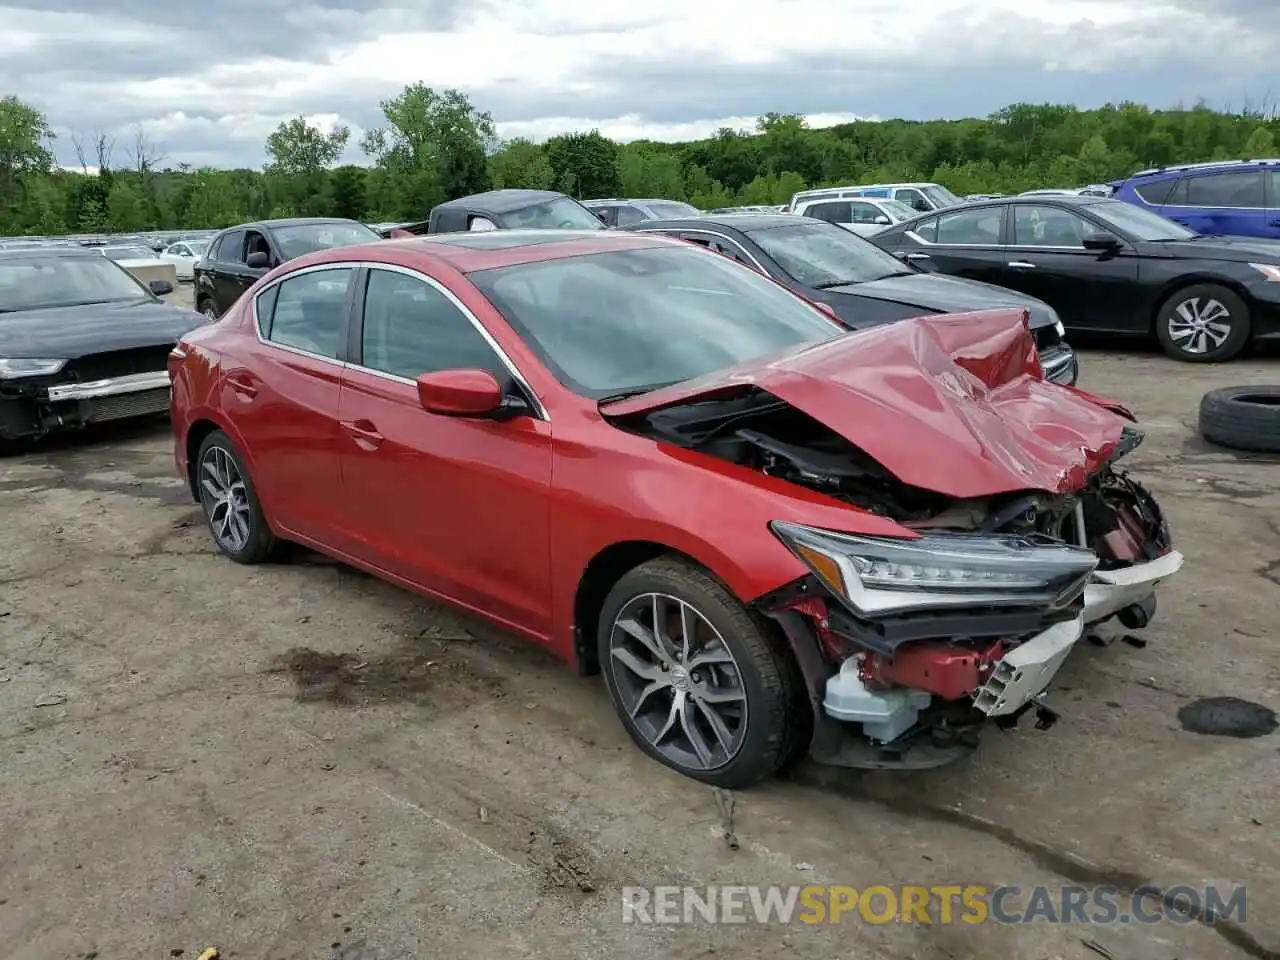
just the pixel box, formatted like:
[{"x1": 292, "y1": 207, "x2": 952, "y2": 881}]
[{"x1": 257, "y1": 266, "x2": 353, "y2": 360}]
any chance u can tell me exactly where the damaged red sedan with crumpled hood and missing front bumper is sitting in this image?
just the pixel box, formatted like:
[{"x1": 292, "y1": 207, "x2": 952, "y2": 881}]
[{"x1": 170, "y1": 230, "x2": 1181, "y2": 787}]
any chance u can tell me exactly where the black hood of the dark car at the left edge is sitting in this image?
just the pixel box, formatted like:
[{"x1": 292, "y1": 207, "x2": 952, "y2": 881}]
[{"x1": 0, "y1": 300, "x2": 205, "y2": 360}]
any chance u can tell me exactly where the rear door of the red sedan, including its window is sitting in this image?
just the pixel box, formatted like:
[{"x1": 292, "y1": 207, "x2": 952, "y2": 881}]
[{"x1": 223, "y1": 266, "x2": 356, "y2": 545}]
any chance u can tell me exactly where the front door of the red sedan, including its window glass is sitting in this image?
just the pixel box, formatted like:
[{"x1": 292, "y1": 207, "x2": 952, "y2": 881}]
[{"x1": 338, "y1": 268, "x2": 552, "y2": 636}]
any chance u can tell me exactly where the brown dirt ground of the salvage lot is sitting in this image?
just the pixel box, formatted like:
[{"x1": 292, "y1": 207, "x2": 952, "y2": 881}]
[{"x1": 0, "y1": 296, "x2": 1280, "y2": 960}]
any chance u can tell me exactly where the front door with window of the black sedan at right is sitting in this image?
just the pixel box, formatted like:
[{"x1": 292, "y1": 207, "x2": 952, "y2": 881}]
[{"x1": 995, "y1": 204, "x2": 1144, "y2": 333}]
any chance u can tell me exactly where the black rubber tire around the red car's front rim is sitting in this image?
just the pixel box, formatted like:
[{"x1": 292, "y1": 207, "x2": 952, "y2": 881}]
[{"x1": 596, "y1": 557, "x2": 804, "y2": 790}]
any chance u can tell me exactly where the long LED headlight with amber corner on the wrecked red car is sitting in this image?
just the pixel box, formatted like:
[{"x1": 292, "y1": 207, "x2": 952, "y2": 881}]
[{"x1": 769, "y1": 521, "x2": 1098, "y2": 614}]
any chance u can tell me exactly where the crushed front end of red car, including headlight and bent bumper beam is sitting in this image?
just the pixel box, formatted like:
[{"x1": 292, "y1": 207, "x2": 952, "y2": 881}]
[{"x1": 760, "y1": 428, "x2": 1183, "y2": 768}]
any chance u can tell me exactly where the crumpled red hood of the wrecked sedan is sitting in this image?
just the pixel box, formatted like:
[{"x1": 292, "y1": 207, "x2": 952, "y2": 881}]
[{"x1": 600, "y1": 310, "x2": 1133, "y2": 498}]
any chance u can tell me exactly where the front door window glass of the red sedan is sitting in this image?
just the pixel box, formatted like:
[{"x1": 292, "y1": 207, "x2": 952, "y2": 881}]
[{"x1": 361, "y1": 269, "x2": 509, "y2": 383}]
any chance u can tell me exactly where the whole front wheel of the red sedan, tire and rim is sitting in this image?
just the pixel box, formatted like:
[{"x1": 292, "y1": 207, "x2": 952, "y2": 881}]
[{"x1": 598, "y1": 558, "x2": 801, "y2": 788}]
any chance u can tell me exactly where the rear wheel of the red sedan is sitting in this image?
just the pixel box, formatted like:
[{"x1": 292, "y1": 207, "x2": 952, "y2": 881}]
[{"x1": 196, "y1": 430, "x2": 276, "y2": 563}]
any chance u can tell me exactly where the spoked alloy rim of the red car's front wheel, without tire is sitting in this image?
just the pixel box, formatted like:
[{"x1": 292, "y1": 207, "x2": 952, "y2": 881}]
[{"x1": 609, "y1": 593, "x2": 748, "y2": 771}]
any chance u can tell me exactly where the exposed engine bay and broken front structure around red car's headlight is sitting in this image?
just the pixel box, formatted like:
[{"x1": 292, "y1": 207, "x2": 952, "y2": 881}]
[{"x1": 617, "y1": 389, "x2": 1181, "y2": 767}]
